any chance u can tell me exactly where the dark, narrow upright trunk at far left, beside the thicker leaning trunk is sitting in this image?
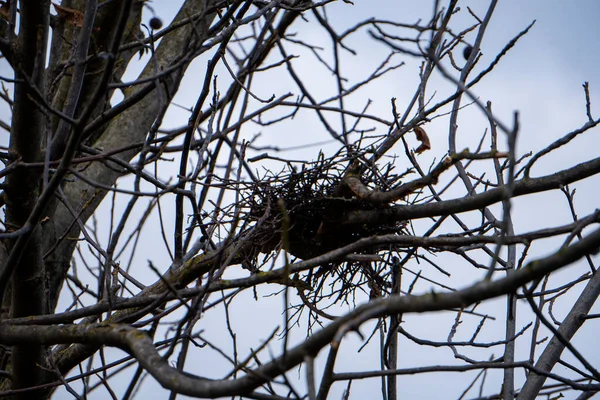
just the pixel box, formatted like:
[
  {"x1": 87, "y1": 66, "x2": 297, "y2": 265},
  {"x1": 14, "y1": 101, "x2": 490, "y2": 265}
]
[{"x1": 5, "y1": 0, "x2": 50, "y2": 399}]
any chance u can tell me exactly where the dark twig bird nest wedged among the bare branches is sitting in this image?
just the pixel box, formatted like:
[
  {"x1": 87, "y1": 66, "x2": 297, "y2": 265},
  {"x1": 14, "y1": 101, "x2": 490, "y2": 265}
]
[{"x1": 247, "y1": 151, "x2": 404, "y2": 260}]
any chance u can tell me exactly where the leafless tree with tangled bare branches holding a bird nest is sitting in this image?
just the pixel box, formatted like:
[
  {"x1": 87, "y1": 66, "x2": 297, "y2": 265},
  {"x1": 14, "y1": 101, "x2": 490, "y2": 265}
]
[{"x1": 0, "y1": 0, "x2": 600, "y2": 400}]
